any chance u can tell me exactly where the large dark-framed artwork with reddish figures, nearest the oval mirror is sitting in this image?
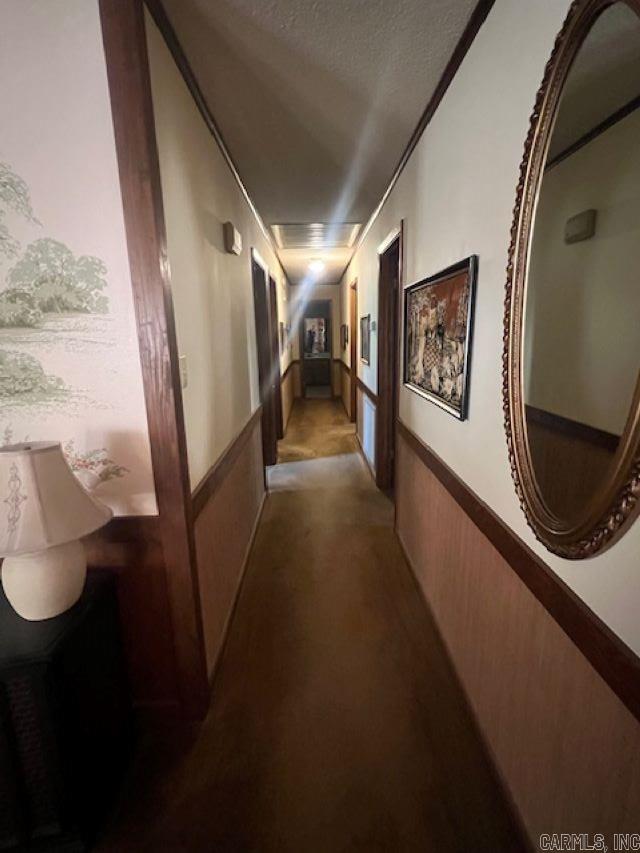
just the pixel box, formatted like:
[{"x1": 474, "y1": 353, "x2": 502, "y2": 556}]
[{"x1": 403, "y1": 255, "x2": 478, "y2": 421}]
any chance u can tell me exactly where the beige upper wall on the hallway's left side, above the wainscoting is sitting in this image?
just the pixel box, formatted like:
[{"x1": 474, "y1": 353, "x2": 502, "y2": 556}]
[{"x1": 146, "y1": 14, "x2": 288, "y2": 488}]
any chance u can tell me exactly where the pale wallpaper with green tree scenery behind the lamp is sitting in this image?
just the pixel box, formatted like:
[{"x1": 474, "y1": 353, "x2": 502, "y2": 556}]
[{"x1": 0, "y1": 0, "x2": 157, "y2": 514}]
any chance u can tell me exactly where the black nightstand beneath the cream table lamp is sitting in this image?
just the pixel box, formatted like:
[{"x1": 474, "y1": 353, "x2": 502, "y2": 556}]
[{"x1": 0, "y1": 570, "x2": 132, "y2": 851}]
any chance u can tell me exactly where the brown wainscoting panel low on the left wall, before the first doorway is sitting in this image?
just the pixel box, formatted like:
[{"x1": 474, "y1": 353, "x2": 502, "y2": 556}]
[{"x1": 194, "y1": 415, "x2": 265, "y2": 678}]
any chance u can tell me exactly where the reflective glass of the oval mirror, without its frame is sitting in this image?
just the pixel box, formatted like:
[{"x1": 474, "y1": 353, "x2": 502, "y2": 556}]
[{"x1": 523, "y1": 2, "x2": 640, "y2": 523}]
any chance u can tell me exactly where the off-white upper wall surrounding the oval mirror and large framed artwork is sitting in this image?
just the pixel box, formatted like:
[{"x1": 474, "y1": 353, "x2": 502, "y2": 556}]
[{"x1": 343, "y1": 0, "x2": 640, "y2": 651}]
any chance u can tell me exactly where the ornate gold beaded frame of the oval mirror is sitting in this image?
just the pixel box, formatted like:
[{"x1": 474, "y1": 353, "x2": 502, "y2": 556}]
[{"x1": 502, "y1": 0, "x2": 640, "y2": 560}]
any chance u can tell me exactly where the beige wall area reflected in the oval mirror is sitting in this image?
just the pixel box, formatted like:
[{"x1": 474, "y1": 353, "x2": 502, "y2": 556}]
[{"x1": 525, "y1": 110, "x2": 640, "y2": 435}]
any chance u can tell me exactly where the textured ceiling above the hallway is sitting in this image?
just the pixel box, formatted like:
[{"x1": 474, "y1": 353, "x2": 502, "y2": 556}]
[{"x1": 164, "y1": 0, "x2": 475, "y2": 280}]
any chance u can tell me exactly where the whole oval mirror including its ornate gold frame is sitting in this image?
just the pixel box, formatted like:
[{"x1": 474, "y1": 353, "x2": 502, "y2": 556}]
[{"x1": 504, "y1": 0, "x2": 640, "y2": 559}]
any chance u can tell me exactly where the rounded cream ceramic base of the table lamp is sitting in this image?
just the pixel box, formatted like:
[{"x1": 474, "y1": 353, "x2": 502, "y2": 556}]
[{"x1": 2, "y1": 539, "x2": 87, "y2": 622}]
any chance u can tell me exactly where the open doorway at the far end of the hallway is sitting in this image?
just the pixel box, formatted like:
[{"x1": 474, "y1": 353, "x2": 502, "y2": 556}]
[{"x1": 300, "y1": 299, "x2": 333, "y2": 399}]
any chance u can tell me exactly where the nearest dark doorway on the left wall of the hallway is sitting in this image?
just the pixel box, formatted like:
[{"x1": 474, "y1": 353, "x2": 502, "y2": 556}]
[{"x1": 251, "y1": 249, "x2": 280, "y2": 465}]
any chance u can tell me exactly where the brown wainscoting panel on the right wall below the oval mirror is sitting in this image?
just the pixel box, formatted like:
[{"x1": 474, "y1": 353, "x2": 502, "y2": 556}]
[{"x1": 396, "y1": 432, "x2": 640, "y2": 849}]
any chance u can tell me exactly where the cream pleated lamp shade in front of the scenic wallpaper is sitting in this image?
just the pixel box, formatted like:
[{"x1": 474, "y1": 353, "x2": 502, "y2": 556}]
[{"x1": 0, "y1": 441, "x2": 112, "y2": 557}]
